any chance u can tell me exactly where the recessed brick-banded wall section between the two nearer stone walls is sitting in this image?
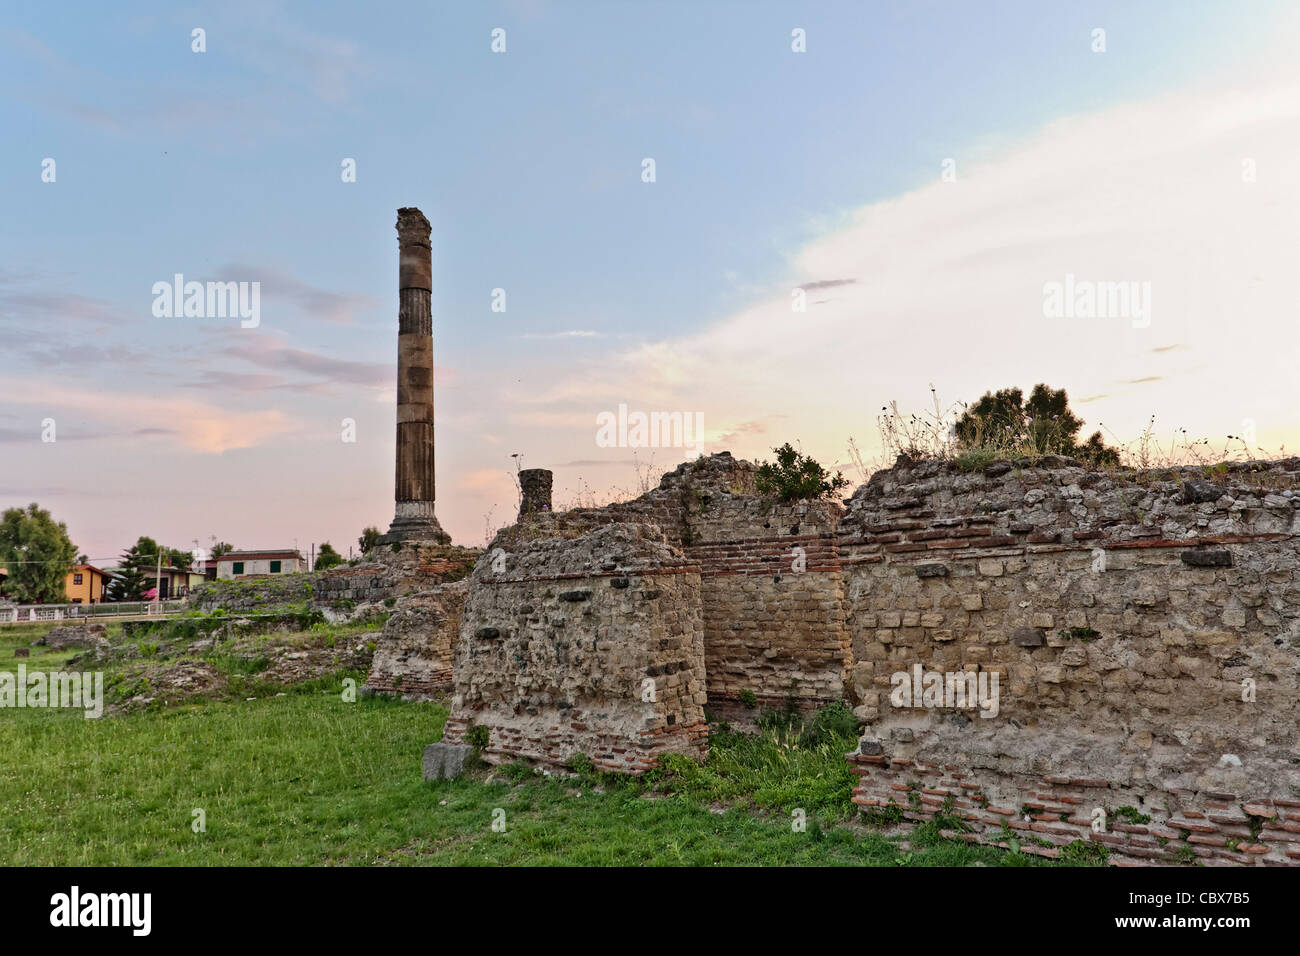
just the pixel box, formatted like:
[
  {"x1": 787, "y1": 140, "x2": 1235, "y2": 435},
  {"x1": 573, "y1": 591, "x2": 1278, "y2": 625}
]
[{"x1": 493, "y1": 453, "x2": 852, "y2": 722}]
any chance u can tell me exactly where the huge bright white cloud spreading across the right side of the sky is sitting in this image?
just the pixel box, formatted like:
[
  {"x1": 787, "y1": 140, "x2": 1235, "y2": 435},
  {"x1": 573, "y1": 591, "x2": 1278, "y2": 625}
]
[{"x1": 520, "y1": 68, "x2": 1300, "y2": 457}]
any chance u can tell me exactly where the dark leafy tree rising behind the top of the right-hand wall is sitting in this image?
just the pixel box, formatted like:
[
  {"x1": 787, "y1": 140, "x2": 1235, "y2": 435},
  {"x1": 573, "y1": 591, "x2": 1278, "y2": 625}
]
[{"x1": 956, "y1": 382, "x2": 1119, "y2": 464}]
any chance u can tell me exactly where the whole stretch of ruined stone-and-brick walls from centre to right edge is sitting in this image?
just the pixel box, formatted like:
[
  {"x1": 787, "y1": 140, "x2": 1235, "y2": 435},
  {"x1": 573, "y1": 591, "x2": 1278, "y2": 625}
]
[{"x1": 371, "y1": 453, "x2": 1300, "y2": 864}]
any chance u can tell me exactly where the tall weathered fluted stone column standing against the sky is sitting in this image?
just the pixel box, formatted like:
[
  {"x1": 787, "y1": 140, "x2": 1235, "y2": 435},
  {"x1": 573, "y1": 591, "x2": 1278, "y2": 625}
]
[{"x1": 380, "y1": 207, "x2": 451, "y2": 544}]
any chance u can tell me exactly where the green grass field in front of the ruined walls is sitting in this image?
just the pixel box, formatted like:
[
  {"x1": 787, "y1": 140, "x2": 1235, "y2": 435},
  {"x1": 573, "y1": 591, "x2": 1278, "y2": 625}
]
[{"x1": 0, "y1": 616, "x2": 1066, "y2": 866}]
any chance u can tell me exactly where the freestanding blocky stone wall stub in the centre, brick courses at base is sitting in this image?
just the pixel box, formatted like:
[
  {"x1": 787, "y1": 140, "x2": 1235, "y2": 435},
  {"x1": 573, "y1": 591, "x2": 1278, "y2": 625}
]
[{"x1": 443, "y1": 523, "x2": 706, "y2": 773}]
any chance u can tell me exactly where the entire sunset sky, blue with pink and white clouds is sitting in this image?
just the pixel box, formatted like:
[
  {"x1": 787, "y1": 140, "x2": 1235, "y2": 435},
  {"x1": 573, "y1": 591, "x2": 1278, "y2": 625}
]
[{"x1": 0, "y1": 0, "x2": 1300, "y2": 563}]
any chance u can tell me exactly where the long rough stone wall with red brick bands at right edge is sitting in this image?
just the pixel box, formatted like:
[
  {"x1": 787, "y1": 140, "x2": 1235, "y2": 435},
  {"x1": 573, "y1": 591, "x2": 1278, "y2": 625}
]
[{"x1": 840, "y1": 459, "x2": 1300, "y2": 862}]
